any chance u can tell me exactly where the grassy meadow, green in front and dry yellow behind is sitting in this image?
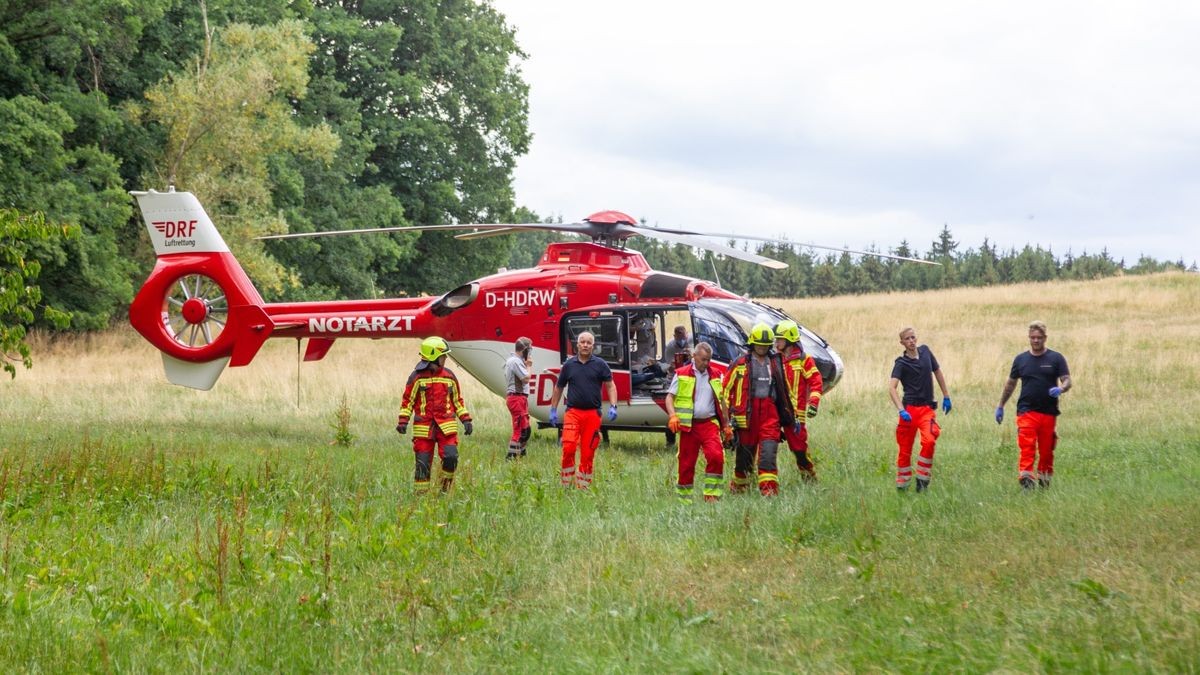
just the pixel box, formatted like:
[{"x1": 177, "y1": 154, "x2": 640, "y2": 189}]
[{"x1": 0, "y1": 273, "x2": 1200, "y2": 673}]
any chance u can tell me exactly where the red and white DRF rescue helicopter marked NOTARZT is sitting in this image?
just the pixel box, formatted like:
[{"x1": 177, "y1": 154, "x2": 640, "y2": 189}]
[{"x1": 130, "y1": 189, "x2": 925, "y2": 431}]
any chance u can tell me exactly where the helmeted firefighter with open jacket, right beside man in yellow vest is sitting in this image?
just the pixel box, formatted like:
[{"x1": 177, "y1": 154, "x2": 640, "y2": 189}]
[{"x1": 725, "y1": 323, "x2": 796, "y2": 496}]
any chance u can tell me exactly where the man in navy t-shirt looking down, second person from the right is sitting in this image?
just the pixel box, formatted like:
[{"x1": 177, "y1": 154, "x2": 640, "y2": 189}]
[{"x1": 888, "y1": 327, "x2": 950, "y2": 492}]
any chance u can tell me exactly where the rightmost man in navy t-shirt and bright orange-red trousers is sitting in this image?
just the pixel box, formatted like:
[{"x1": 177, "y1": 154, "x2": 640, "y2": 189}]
[{"x1": 996, "y1": 321, "x2": 1072, "y2": 489}]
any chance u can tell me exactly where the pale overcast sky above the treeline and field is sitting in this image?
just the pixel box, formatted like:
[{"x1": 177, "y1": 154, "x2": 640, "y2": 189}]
[{"x1": 493, "y1": 0, "x2": 1200, "y2": 264}]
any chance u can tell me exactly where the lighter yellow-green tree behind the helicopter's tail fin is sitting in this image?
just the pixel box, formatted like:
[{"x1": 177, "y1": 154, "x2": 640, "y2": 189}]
[{"x1": 144, "y1": 19, "x2": 338, "y2": 293}]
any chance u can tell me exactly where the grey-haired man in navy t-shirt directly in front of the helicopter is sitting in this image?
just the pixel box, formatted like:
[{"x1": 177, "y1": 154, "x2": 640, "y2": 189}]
[{"x1": 550, "y1": 330, "x2": 617, "y2": 489}]
